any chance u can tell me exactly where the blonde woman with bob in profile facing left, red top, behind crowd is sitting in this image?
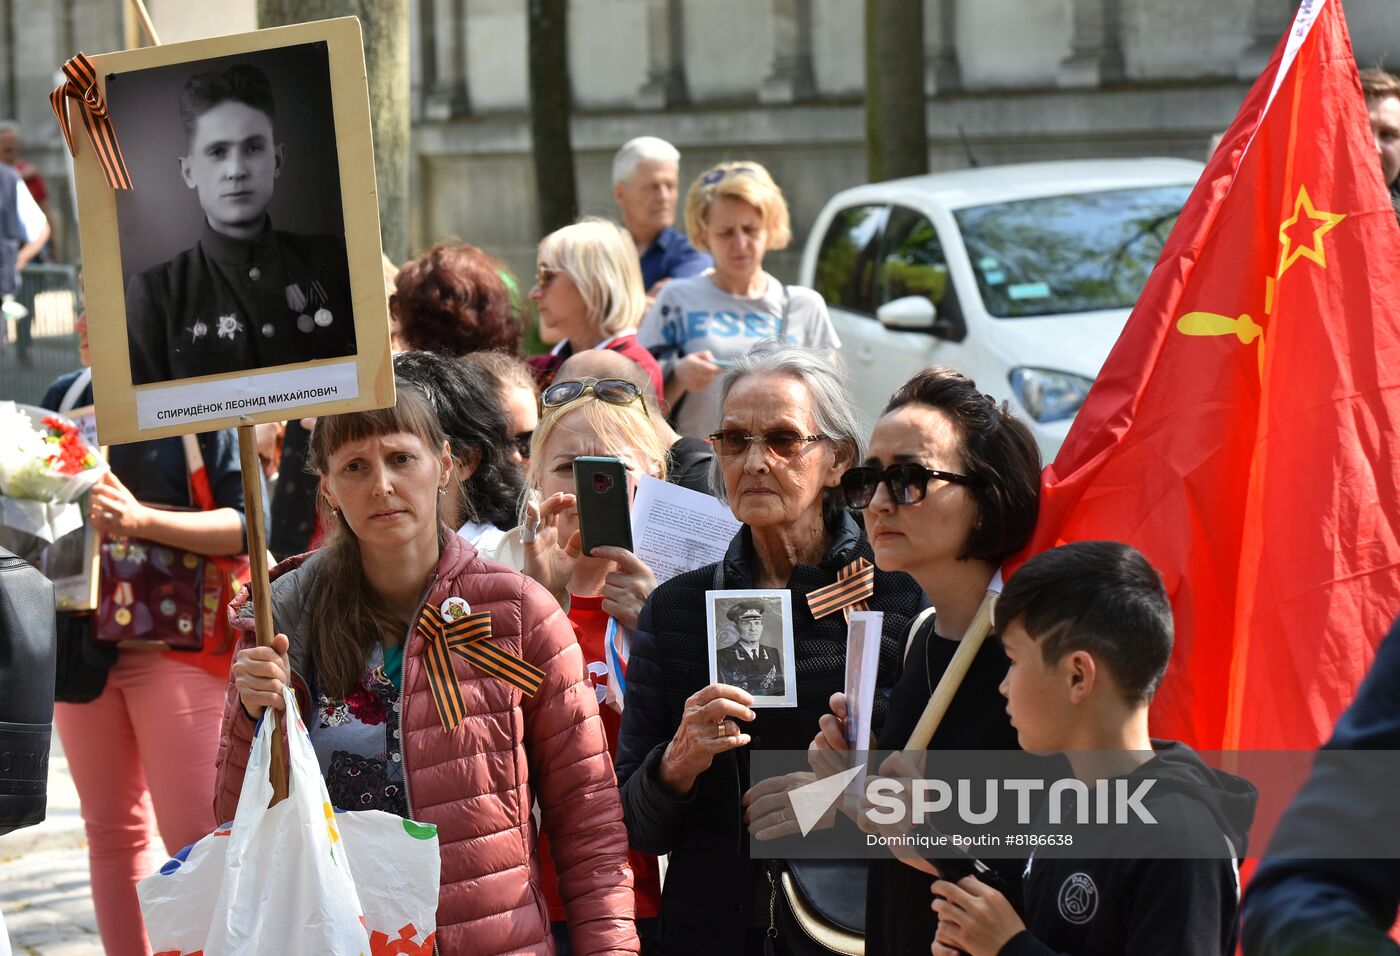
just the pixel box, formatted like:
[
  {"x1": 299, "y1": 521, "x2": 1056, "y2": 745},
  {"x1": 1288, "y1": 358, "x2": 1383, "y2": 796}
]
[{"x1": 529, "y1": 217, "x2": 661, "y2": 392}]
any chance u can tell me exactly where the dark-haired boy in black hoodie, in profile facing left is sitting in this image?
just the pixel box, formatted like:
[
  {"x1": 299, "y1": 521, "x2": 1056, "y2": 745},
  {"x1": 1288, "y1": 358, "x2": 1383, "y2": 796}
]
[{"x1": 932, "y1": 542, "x2": 1257, "y2": 956}]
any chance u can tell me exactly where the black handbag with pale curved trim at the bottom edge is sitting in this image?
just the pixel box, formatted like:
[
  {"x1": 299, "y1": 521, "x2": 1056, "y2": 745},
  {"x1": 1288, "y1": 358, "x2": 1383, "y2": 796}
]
[{"x1": 766, "y1": 859, "x2": 869, "y2": 956}]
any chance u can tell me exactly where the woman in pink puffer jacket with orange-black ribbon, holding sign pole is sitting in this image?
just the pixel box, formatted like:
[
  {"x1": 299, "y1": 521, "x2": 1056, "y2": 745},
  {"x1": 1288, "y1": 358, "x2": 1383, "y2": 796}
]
[{"x1": 214, "y1": 384, "x2": 638, "y2": 953}]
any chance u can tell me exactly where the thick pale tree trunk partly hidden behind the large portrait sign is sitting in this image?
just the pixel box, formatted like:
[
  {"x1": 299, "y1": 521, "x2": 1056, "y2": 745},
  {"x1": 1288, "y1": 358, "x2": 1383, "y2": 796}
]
[{"x1": 258, "y1": 0, "x2": 409, "y2": 262}]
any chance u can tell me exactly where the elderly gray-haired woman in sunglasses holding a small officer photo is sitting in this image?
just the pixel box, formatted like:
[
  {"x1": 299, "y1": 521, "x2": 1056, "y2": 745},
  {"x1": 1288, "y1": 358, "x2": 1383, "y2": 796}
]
[{"x1": 617, "y1": 340, "x2": 921, "y2": 953}]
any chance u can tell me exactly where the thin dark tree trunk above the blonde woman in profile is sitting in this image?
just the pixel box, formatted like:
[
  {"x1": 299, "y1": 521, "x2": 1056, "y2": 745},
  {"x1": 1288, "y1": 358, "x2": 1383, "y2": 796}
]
[{"x1": 529, "y1": 0, "x2": 578, "y2": 235}]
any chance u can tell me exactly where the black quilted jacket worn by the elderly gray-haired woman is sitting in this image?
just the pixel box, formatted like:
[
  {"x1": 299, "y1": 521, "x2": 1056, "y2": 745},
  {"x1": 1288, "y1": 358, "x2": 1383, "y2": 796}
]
[{"x1": 617, "y1": 512, "x2": 923, "y2": 956}]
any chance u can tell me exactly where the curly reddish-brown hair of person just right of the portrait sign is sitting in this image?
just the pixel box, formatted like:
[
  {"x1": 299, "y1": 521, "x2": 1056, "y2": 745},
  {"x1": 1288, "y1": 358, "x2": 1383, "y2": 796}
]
[{"x1": 389, "y1": 244, "x2": 524, "y2": 357}]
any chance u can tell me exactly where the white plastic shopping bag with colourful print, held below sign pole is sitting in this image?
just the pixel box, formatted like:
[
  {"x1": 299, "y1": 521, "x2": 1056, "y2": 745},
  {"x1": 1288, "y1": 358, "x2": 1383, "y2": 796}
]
[{"x1": 137, "y1": 690, "x2": 440, "y2": 956}]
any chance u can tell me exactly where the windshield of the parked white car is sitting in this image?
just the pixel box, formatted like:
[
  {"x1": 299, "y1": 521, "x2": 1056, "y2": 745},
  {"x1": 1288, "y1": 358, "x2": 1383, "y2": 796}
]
[{"x1": 953, "y1": 185, "x2": 1191, "y2": 319}]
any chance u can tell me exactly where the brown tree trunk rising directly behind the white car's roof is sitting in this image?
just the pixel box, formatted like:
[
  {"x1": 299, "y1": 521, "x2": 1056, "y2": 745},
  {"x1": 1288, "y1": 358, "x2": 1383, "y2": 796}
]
[{"x1": 865, "y1": 0, "x2": 928, "y2": 182}]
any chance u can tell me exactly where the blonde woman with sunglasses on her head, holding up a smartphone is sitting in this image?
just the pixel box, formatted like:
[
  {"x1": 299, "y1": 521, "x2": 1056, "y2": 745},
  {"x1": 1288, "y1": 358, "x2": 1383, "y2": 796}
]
[{"x1": 511, "y1": 375, "x2": 669, "y2": 943}]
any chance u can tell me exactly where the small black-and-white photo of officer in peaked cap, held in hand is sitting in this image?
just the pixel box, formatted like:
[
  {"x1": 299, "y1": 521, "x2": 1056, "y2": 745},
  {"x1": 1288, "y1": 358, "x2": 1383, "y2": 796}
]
[{"x1": 706, "y1": 591, "x2": 797, "y2": 707}]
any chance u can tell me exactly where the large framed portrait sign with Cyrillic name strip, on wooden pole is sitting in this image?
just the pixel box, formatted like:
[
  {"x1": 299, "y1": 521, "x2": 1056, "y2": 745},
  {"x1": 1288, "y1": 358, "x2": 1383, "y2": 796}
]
[{"x1": 73, "y1": 17, "x2": 393, "y2": 444}]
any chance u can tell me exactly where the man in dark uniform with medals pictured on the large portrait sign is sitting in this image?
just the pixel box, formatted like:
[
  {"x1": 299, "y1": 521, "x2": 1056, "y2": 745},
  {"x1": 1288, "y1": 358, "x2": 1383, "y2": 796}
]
[{"x1": 126, "y1": 63, "x2": 356, "y2": 385}]
